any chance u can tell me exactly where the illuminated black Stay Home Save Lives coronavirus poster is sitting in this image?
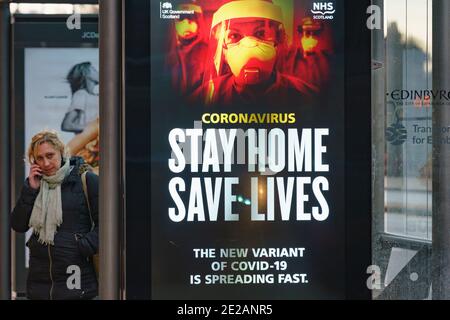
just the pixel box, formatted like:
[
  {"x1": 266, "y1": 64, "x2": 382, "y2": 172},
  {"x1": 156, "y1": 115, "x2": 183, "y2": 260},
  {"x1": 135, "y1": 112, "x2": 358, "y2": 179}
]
[{"x1": 149, "y1": 0, "x2": 346, "y2": 299}]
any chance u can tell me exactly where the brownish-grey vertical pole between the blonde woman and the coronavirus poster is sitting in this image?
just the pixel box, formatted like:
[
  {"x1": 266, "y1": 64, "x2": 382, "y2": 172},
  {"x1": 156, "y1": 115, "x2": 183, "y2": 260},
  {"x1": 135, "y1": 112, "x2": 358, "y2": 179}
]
[{"x1": 99, "y1": 0, "x2": 123, "y2": 300}]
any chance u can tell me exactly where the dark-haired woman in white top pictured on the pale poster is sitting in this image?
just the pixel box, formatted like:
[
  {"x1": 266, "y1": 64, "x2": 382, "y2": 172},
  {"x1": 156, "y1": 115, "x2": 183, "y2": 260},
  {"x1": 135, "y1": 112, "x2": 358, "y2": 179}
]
[{"x1": 61, "y1": 62, "x2": 99, "y2": 134}]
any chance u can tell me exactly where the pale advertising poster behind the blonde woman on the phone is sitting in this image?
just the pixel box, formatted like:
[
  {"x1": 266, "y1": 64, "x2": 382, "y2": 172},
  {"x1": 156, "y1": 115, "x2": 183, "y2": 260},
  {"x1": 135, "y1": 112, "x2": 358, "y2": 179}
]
[{"x1": 23, "y1": 48, "x2": 99, "y2": 266}]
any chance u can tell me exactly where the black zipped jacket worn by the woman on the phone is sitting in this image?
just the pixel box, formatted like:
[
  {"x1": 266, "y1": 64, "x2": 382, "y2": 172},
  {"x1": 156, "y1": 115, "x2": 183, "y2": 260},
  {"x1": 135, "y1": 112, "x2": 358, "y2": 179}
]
[{"x1": 11, "y1": 157, "x2": 98, "y2": 300}]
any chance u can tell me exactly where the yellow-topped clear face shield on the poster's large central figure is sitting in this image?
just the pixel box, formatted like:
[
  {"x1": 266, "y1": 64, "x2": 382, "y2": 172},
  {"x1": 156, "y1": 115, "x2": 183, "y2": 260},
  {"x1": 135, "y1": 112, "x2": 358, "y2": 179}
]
[{"x1": 206, "y1": 0, "x2": 285, "y2": 86}]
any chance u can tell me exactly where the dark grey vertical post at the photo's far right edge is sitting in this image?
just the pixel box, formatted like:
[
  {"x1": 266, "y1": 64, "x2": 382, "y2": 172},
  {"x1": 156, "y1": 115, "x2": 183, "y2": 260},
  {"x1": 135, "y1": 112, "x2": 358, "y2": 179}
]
[{"x1": 432, "y1": 0, "x2": 450, "y2": 300}]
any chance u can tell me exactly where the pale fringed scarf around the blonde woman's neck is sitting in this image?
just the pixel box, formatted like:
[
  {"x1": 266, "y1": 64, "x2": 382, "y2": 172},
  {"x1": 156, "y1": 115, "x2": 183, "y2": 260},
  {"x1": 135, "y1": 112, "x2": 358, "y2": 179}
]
[{"x1": 29, "y1": 159, "x2": 70, "y2": 245}]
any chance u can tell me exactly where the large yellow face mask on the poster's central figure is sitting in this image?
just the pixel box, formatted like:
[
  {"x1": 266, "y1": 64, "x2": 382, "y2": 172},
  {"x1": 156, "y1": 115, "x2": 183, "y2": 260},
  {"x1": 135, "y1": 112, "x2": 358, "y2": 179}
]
[{"x1": 225, "y1": 36, "x2": 277, "y2": 85}]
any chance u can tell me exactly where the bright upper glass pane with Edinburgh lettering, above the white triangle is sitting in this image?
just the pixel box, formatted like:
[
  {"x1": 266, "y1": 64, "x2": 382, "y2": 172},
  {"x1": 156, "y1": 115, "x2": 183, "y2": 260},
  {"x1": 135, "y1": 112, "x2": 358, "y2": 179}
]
[{"x1": 385, "y1": 0, "x2": 432, "y2": 240}]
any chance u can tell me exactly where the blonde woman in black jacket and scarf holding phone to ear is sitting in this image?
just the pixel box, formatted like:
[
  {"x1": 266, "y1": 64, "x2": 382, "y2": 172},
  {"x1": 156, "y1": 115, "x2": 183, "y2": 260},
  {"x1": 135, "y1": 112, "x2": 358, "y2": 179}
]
[{"x1": 11, "y1": 131, "x2": 98, "y2": 299}]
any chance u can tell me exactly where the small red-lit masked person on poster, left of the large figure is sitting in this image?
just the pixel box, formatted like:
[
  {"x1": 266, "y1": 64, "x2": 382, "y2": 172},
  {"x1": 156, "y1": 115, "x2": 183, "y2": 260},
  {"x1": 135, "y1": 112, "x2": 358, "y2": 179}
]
[{"x1": 167, "y1": 3, "x2": 208, "y2": 95}]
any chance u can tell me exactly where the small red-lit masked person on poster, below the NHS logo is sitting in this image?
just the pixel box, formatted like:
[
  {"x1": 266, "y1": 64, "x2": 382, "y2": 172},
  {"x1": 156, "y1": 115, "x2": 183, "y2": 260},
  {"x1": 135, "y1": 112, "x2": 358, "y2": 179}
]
[{"x1": 283, "y1": 17, "x2": 331, "y2": 88}]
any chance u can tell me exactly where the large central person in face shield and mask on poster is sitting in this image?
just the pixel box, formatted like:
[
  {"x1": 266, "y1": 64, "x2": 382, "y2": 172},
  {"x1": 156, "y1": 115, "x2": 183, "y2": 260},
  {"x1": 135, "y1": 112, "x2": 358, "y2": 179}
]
[{"x1": 193, "y1": 0, "x2": 315, "y2": 106}]
